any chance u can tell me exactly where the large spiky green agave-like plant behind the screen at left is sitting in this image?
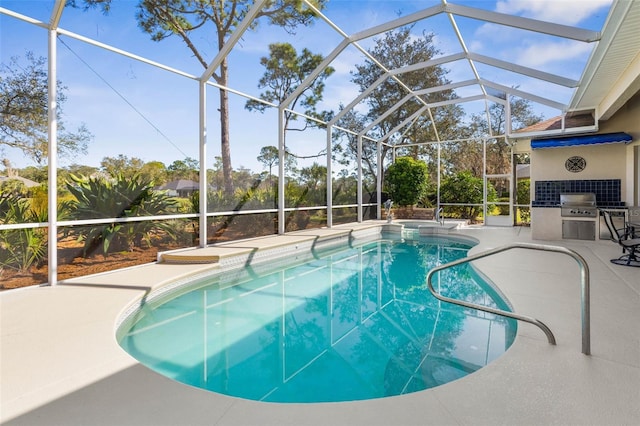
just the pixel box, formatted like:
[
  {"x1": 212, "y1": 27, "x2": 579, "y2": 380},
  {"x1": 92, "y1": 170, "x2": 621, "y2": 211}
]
[{"x1": 67, "y1": 174, "x2": 177, "y2": 256}]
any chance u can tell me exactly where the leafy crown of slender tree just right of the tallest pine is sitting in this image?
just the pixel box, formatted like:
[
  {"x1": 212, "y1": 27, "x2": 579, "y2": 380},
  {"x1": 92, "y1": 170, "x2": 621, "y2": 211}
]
[{"x1": 245, "y1": 43, "x2": 334, "y2": 148}]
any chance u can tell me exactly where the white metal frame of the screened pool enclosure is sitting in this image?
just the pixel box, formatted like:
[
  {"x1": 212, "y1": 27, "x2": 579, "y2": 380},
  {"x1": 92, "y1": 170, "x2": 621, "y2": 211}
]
[{"x1": 0, "y1": 0, "x2": 617, "y2": 285}]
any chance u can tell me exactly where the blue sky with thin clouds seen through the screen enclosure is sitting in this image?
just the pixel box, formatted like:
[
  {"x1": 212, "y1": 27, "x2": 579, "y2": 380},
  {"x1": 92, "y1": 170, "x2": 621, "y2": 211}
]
[{"x1": 0, "y1": 0, "x2": 625, "y2": 176}]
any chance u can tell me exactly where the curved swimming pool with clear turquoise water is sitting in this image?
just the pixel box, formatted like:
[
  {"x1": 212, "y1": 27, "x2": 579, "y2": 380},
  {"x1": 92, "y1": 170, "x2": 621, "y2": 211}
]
[{"x1": 118, "y1": 235, "x2": 516, "y2": 402}]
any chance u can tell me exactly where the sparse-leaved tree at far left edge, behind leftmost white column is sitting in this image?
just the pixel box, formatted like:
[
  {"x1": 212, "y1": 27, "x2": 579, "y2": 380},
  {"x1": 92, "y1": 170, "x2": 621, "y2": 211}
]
[{"x1": 0, "y1": 52, "x2": 93, "y2": 165}]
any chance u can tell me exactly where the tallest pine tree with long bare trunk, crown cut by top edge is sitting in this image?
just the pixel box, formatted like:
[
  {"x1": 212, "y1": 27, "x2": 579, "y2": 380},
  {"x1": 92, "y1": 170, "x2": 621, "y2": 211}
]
[{"x1": 70, "y1": 0, "x2": 326, "y2": 195}]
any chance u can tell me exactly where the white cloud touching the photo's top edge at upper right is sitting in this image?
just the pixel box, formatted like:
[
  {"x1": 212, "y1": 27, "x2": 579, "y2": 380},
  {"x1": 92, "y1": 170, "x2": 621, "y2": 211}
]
[{"x1": 496, "y1": 0, "x2": 612, "y2": 25}]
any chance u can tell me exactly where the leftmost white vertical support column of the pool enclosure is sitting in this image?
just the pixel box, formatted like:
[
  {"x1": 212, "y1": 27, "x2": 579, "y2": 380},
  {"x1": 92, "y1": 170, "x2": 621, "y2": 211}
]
[{"x1": 47, "y1": 29, "x2": 58, "y2": 285}]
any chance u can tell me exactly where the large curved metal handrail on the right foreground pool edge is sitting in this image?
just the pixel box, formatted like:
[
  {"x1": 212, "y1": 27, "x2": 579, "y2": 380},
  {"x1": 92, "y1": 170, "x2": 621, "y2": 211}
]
[{"x1": 427, "y1": 243, "x2": 591, "y2": 355}]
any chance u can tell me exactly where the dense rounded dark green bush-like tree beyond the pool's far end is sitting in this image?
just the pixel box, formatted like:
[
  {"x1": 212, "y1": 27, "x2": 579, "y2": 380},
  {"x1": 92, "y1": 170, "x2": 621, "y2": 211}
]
[{"x1": 385, "y1": 157, "x2": 429, "y2": 206}]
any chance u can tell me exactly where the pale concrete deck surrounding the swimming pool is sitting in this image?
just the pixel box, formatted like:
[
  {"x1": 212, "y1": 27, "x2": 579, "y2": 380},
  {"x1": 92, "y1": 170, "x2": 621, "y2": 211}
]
[{"x1": 0, "y1": 222, "x2": 640, "y2": 425}]
